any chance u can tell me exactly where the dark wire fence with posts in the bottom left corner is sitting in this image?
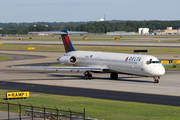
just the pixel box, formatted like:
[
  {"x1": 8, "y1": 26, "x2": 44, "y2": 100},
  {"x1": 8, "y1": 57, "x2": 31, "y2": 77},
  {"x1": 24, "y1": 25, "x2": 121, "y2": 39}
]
[{"x1": 0, "y1": 101, "x2": 97, "y2": 120}]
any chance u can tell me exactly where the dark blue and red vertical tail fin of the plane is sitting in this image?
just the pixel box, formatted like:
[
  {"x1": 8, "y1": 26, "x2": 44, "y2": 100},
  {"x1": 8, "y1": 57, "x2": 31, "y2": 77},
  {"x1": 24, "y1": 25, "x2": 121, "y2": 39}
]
[{"x1": 61, "y1": 30, "x2": 76, "y2": 53}]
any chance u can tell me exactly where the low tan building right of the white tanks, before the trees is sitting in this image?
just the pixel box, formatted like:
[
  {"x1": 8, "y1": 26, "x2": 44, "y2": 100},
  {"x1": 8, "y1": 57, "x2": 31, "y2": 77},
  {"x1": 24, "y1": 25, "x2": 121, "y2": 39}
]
[{"x1": 153, "y1": 27, "x2": 178, "y2": 35}]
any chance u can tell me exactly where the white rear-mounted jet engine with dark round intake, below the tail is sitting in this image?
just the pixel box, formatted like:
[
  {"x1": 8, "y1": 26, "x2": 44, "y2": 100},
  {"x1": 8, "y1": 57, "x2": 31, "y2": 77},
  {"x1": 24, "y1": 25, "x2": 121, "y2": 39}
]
[{"x1": 57, "y1": 56, "x2": 77, "y2": 65}]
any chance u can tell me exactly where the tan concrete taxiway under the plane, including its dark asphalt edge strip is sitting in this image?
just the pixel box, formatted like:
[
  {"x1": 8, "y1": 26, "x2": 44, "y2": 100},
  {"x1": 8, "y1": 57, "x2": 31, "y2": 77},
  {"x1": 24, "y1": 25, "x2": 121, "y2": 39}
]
[{"x1": 0, "y1": 51, "x2": 180, "y2": 106}]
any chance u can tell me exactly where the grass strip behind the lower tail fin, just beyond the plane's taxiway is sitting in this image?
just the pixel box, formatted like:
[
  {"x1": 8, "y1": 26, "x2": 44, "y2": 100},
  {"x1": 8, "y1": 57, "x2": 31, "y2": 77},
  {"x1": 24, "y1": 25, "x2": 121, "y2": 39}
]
[{"x1": 0, "y1": 44, "x2": 180, "y2": 54}]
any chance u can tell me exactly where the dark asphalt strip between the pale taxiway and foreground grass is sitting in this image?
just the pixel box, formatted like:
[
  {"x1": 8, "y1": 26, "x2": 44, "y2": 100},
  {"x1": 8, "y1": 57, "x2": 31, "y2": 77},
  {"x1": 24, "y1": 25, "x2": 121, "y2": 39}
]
[{"x1": 0, "y1": 81, "x2": 180, "y2": 106}]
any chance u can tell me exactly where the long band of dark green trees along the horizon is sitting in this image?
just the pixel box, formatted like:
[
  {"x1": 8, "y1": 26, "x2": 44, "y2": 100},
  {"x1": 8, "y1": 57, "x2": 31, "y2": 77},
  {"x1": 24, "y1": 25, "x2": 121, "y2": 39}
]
[{"x1": 0, "y1": 21, "x2": 180, "y2": 34}]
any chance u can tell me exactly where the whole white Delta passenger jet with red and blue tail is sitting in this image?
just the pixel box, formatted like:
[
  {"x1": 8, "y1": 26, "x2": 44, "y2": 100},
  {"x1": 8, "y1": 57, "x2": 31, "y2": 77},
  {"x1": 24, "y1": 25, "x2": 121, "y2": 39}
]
[{"x1": 11, "y1": 30, "x2": 169, "y2": 83}]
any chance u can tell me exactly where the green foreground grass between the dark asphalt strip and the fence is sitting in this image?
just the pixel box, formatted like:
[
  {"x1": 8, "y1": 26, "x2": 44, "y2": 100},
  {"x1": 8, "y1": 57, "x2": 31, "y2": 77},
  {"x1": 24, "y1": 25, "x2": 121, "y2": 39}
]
[{"x1": 0, "y1": 90, "x2": 180, "y2": 120}]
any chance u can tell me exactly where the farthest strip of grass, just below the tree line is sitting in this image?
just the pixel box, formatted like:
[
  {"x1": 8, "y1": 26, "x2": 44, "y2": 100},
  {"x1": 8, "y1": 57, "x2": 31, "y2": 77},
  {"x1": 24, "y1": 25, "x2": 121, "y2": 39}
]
[{"x1": 1, "y1": 33, "x2": 180, "y2": 41}]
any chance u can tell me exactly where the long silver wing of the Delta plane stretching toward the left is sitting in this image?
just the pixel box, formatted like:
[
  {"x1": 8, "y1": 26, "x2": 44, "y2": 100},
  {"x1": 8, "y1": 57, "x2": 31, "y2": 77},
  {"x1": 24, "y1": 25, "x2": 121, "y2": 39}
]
[{"x1": 9, "y1": 66, "x2": 103, "y2": 71}]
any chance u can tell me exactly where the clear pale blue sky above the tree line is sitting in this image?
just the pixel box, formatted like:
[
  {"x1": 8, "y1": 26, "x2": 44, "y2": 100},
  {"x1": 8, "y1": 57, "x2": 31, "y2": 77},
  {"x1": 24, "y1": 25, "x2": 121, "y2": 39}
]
[{"x1": 0, "y1": 0, "x2": 180, "y2": 23}]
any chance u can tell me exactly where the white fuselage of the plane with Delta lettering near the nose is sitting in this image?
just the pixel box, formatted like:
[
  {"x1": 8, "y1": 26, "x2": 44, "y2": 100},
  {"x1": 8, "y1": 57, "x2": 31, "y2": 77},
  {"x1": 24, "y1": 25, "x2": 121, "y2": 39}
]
[{"x1": 59, "y1": 51, "x2": 165, "y2": 77}]
